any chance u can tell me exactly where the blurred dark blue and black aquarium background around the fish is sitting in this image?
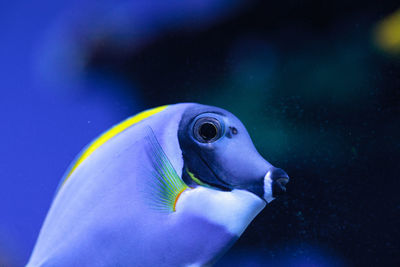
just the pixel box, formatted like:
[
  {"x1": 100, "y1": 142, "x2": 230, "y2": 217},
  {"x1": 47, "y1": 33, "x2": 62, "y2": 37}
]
[{"x1": 0, "y1": 0, "x2": 400, "y2": 266}]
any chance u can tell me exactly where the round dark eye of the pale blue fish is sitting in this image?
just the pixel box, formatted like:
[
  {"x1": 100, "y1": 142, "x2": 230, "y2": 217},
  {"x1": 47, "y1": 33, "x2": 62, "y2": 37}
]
[{"x1": 193, "y1": 117, "x2": 222, "y2": 143}]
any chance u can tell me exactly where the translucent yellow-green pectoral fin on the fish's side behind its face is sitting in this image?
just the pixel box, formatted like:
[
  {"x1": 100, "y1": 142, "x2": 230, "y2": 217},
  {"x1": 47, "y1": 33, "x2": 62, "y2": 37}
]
[{"x1": 145, "y1": 127, "x2": 189, "y2": 213}]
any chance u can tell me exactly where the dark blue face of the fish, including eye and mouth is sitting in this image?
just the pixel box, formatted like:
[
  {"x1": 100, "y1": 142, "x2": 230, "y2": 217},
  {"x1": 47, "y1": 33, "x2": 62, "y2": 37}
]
[{"x1": 178, "y1": 104, "x2": 289, "y2": 202}]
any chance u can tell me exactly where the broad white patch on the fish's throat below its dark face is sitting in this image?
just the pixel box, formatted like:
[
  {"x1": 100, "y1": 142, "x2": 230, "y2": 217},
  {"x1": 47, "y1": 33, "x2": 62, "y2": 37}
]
[{"x1": 176, "y1": 186, "x2": 266, "y2": 236}]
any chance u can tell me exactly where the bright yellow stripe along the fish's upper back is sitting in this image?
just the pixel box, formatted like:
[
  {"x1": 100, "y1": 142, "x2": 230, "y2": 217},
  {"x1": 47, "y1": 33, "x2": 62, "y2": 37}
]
[{"x1": 61, "y1": 105, "x2": 167, "y2": 186}]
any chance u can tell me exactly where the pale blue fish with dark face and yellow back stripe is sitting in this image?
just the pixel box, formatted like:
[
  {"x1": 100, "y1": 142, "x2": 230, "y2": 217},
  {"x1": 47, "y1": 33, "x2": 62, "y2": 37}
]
[{"x1": 27, "y1": 103, "x2": 289, "y2": 267}]
